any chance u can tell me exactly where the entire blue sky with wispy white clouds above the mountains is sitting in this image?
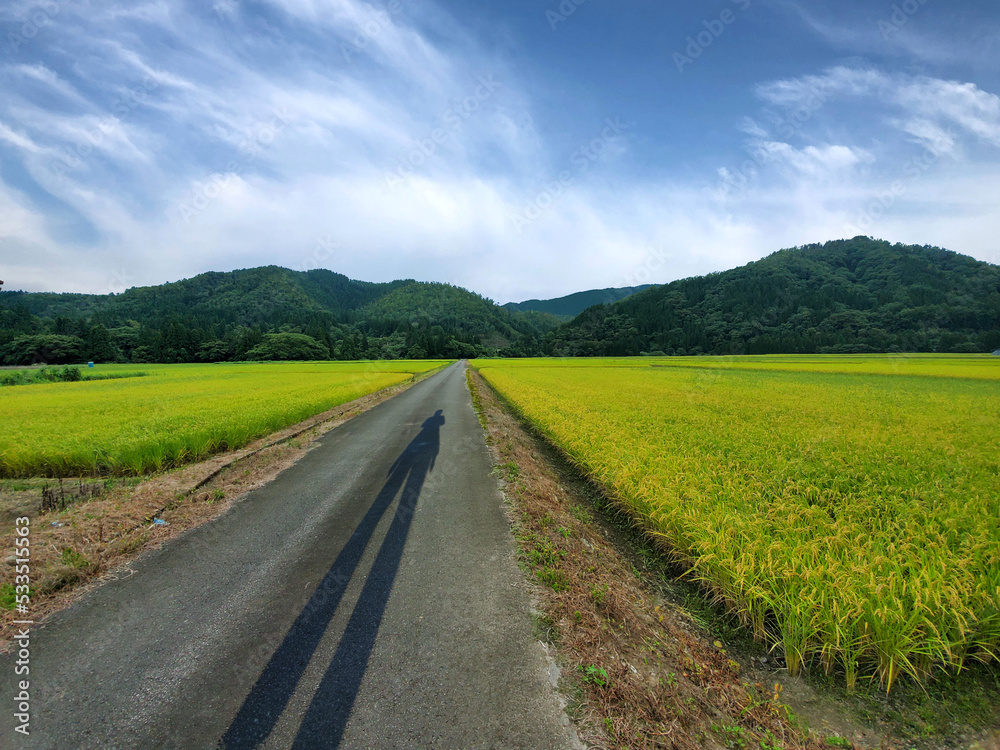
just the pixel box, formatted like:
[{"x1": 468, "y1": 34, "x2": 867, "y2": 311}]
[{"x1": 0, "y1": 0, "x2": 1000, "y2": 303}]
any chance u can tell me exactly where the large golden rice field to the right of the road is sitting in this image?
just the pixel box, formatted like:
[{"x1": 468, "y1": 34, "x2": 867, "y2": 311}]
[{"x1": 476, "y1": 356, "x2": 1000, "y2": 689}]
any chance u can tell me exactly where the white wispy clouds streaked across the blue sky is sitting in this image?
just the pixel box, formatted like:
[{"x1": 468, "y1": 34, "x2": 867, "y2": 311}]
[{"x1": 0, "y1": 0, "x2": 1000, "y2": 301}]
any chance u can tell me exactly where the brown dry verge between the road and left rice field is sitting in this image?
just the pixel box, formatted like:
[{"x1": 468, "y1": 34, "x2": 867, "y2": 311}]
[{"x1": 0, "y1": 371, "x2": 437, "y2": 651}]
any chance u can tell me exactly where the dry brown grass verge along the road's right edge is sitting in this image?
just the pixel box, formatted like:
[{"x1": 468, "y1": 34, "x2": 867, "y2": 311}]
[{"x1": 470, "y1": 371, "x2": 860, "y2": 750}]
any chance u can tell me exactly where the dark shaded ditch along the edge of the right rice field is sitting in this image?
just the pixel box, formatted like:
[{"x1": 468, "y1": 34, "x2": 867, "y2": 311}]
[{"x1": 470, "y1": 368, "x2": 1000, "y2": 750}]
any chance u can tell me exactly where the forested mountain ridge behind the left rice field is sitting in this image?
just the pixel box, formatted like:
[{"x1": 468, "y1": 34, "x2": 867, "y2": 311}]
[{"x1": 0, "y1": 266, "x2": 558, "y2": 364}]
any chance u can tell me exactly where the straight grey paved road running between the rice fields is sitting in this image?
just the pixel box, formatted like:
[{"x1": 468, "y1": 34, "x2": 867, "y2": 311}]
[{"x1": 0, "y1": 364, "x2": 577, "y2": 750}]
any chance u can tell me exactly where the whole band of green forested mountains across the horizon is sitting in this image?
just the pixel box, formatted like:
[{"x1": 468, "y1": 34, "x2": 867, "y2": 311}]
[{"x1": 0, "y1": 237, "x2": 1000, "y2": 365}]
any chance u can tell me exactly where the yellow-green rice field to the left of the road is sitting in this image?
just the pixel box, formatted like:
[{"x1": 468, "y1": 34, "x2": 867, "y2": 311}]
[{"x1": 0, "y1": 361, "x2": 445, "y2": 477}]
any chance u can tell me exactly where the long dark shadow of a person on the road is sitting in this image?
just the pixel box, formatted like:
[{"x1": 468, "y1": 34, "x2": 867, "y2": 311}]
[{"x1": 225, "y1": 409, "x2": 445, "y2": 750}]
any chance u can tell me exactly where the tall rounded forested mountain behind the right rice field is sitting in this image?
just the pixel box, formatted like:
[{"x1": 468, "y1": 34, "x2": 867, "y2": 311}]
[{"x1": 546, "y1": 237, "x2": 1000, "y2": 356}]
